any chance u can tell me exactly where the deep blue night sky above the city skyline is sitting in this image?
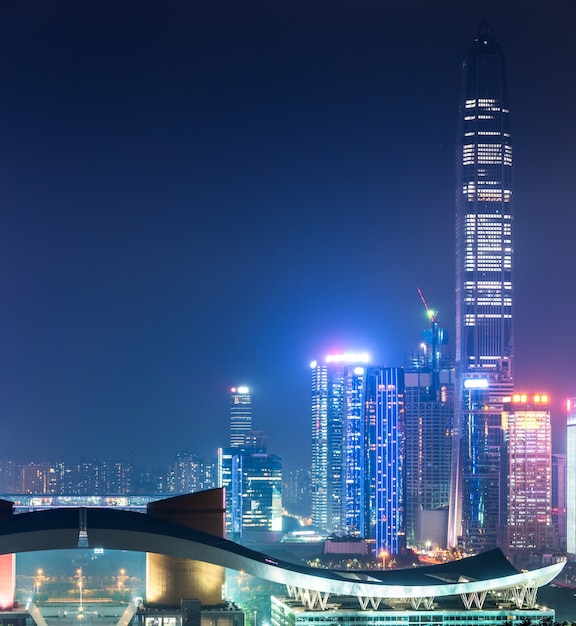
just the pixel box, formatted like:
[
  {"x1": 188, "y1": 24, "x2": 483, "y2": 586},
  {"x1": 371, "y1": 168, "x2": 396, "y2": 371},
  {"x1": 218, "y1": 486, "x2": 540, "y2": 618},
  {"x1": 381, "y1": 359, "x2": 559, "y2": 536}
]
[{"x1": 0, "y1": 0, "x2": 576, "y2": 467}]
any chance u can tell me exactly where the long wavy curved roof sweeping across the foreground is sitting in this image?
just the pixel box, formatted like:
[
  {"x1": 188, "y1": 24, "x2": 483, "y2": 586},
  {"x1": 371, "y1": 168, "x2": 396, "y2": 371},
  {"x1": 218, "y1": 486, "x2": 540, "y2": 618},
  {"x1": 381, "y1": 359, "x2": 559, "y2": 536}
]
[{"x1": 0, "y1": 508, "x2": 564, "y2": 599}]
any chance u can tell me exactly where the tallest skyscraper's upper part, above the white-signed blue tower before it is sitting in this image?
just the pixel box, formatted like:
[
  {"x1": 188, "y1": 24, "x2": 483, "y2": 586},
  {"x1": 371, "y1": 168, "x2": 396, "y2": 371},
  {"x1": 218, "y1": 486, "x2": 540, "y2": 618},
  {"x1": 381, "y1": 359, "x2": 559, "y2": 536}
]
[{"x1": 456, "y1": 23, "x2": 513, "y2": 374}]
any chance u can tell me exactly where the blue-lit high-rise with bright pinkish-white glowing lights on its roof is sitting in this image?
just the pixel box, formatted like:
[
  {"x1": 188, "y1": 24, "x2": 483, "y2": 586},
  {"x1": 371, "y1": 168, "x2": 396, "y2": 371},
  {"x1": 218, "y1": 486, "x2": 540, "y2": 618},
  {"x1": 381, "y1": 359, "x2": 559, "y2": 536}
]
[{"x1": 310, "y1": 353, "x2": 369, "y2": 534}]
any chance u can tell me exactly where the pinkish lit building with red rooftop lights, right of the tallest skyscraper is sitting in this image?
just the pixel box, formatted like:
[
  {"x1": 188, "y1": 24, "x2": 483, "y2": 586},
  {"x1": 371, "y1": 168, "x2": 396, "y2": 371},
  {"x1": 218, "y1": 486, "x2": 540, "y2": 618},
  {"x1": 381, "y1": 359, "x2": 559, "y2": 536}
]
[{"x1": 502, "y1": 394, "x2": 554, "y2": 553}]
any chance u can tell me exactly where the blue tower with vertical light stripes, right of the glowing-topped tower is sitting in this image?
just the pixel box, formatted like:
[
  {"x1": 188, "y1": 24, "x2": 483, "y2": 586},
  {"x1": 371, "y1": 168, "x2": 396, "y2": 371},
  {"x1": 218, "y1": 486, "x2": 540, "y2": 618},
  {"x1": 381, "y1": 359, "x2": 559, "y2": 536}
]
[{"x1": 362, "y1": 367, "x2": 406, "y2": 555}]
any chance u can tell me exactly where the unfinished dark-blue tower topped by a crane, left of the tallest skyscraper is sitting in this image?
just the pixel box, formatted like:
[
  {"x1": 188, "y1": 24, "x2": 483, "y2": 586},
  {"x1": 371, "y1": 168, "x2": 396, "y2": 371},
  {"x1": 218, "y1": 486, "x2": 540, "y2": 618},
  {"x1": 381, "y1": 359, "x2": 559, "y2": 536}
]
[{"x1": 404, "y1": 320, "x2": 455, "y2": 547}]
